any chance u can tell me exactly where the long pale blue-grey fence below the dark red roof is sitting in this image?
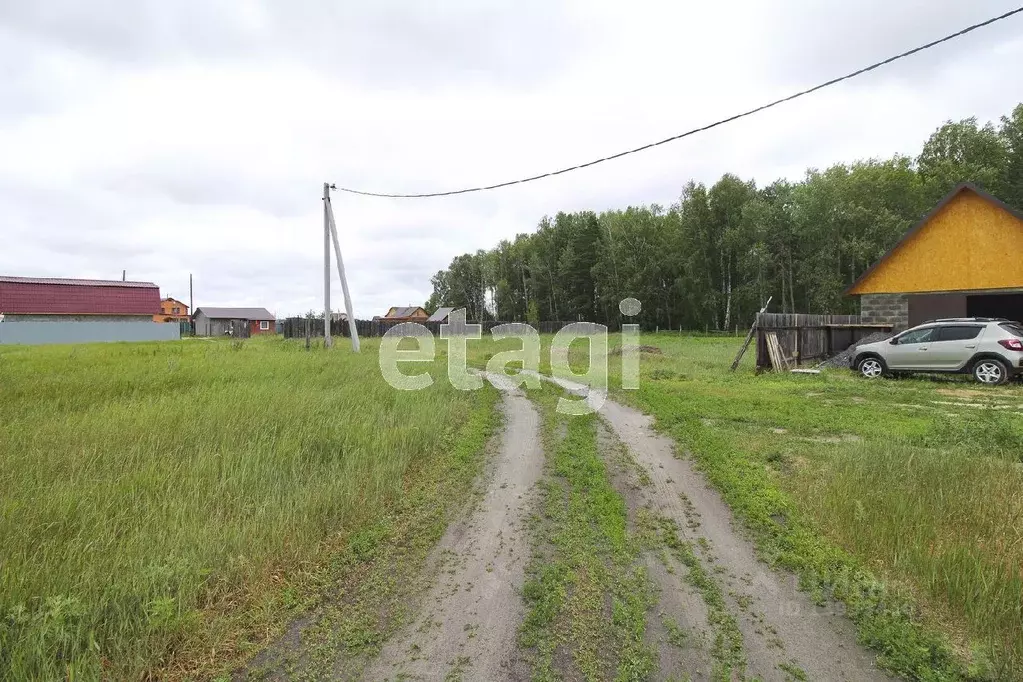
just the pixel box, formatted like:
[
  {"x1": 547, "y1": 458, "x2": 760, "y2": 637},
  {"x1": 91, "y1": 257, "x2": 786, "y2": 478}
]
[{"x1": 0, "y1": 317, "x2": 181, "y2": 346}]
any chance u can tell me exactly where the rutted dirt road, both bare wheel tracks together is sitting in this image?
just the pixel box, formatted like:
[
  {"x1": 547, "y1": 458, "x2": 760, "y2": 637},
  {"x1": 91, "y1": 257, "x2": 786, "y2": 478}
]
[{"x1": 247, "y1": 376, "x2": 889, "y2": 682}]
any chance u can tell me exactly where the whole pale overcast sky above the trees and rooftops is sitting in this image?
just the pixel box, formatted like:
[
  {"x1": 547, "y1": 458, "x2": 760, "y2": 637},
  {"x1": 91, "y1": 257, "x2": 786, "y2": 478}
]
[{"x1": 0, "y1": 0, "x2": 1023, "y2": 317}]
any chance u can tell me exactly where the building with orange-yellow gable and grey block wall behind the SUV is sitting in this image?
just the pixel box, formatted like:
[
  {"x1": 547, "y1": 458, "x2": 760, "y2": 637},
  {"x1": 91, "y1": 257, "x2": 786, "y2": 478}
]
[{"x1": 846, "y1": 183, "x2": 1023, "y2": 328}]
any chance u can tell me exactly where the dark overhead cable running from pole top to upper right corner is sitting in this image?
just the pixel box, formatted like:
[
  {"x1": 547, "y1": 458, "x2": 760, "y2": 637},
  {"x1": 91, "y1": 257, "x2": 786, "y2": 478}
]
[{"x1": 338, "y1": 7, "x2": 1023, "y2": 199}]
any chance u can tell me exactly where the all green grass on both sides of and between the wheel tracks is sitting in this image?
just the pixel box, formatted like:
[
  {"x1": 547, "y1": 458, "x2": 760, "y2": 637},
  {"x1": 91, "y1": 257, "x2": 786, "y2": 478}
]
[{"x1": 0, "y1": 334, "x2": 1023, "y2": 680}]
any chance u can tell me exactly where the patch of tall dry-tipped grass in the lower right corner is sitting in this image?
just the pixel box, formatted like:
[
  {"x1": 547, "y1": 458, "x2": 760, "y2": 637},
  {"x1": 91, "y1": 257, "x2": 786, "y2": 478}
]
[{"x1": 800, "y1": 445, "x2": 1023, "y2": 679}]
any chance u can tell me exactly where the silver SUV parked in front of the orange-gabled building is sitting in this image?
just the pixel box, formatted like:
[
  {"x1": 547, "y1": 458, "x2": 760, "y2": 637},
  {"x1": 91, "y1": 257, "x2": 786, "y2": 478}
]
[{"x1": 850, "y1": 317, "x2": 1023, "y2": 384}]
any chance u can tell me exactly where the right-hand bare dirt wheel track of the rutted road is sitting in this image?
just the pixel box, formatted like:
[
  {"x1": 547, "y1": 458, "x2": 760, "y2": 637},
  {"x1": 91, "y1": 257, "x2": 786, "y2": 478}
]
[{"x1": 531, "y1": 376, "x2": 890, "y2": 682}]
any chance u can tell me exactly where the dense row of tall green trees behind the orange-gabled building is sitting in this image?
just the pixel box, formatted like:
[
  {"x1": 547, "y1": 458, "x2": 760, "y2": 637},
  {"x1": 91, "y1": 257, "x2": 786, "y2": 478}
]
[{"x1": 427, "y1": 104, "x2": 1023, "y2": 329}]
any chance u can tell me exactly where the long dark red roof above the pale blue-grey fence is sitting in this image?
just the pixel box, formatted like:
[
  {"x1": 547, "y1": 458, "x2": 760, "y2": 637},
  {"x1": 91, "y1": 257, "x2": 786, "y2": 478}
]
[{"x1": 0, "y1": 276, "x2": 160, "y2": 315}]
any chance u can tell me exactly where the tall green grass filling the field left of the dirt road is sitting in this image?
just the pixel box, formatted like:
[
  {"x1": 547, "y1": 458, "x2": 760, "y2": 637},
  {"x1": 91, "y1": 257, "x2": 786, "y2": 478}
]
[{"x1": 0, "y1": 339, "x2": 473, "y2": 680}]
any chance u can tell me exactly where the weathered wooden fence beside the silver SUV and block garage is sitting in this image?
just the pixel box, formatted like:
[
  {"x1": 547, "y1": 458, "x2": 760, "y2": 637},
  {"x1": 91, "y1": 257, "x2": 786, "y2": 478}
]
[{"x1": 757, "y1": 313, "x2": 892, "y2": 370}]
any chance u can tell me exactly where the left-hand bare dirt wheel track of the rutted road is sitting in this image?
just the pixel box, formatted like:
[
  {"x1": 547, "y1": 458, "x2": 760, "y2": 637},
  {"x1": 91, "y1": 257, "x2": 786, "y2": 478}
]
[{"x1": 363, "y1": 376, "x2": 543, "y2": 681}]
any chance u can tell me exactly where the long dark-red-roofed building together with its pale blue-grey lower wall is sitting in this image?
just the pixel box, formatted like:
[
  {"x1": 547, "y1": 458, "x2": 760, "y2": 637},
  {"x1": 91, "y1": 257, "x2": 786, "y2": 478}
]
[{"x1": 0, "y1": 275, "x2": 181, "y2": 344}]
